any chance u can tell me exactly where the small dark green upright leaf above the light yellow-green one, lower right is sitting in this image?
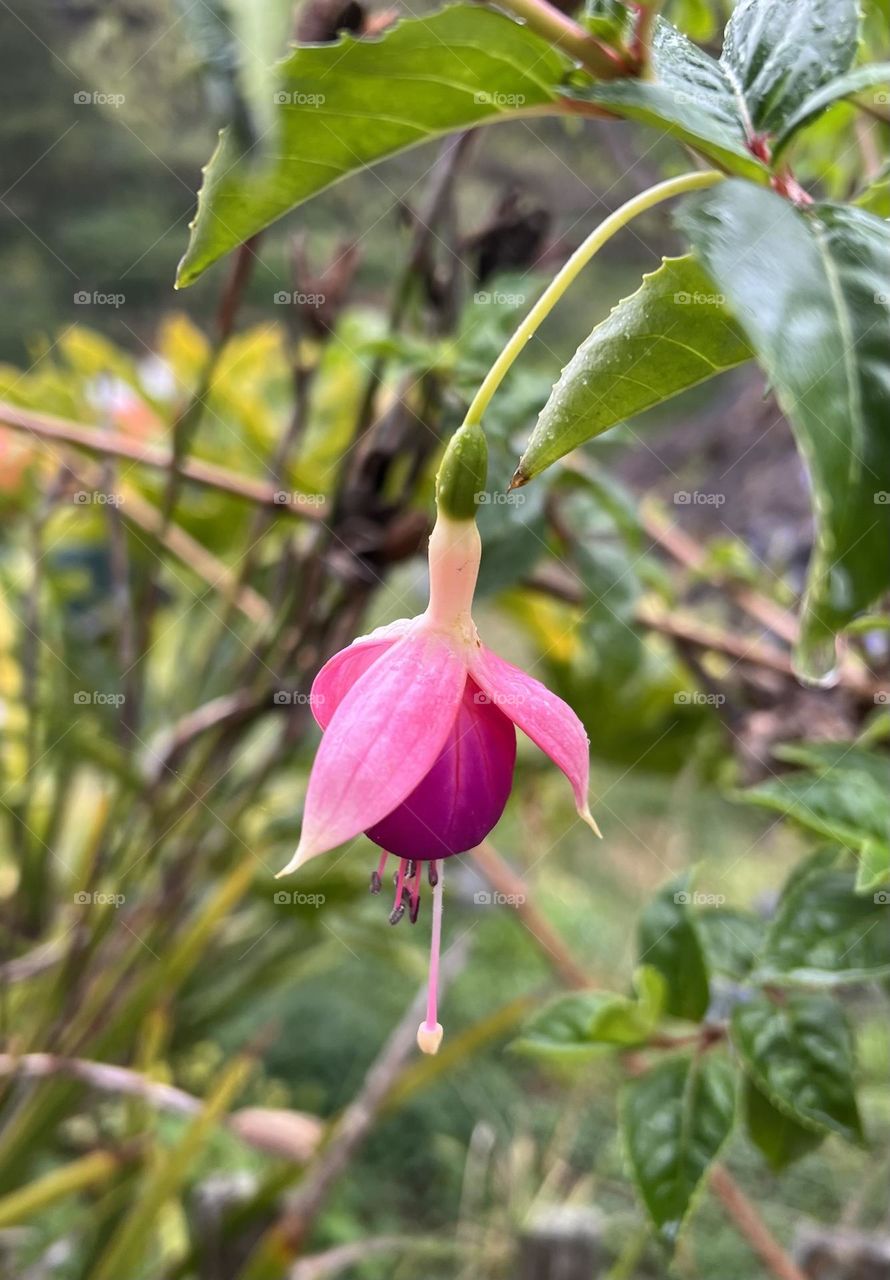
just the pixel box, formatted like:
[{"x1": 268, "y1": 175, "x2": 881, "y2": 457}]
[{"x1": 639, "y1": 876, "x2": 711, "y2": 1023}]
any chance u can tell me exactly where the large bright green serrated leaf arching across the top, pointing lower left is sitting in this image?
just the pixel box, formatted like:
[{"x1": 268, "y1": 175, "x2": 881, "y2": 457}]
[{"x1": 177, "y1": 4, "x2": 569, "y2": 287}]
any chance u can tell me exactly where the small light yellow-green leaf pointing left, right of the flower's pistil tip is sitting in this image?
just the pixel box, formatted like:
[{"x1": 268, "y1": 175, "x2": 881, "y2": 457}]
[{"x1": 512, "y1": 965, "x2": 665, "y2": 1062}]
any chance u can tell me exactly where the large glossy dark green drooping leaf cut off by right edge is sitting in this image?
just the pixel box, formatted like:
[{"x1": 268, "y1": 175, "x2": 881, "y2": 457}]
[{"x1": 679, "y1": 179, "x2": 890, "y2": 660}]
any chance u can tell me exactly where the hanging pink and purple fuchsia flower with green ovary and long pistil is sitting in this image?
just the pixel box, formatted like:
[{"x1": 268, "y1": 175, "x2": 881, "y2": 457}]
[{"x1": 279, "y1": 426, "x2": 599, "y2": 1053}]
